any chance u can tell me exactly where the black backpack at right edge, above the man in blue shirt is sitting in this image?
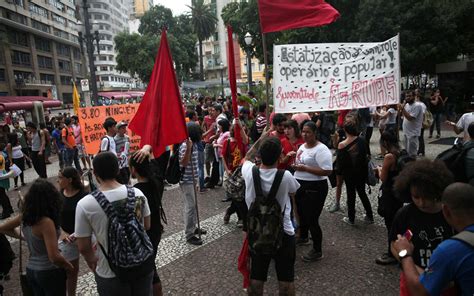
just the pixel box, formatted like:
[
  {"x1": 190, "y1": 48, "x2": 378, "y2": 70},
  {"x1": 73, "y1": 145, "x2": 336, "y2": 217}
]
[{"x1": 436, "y1": 142, "x2": 474, "y2": 183}]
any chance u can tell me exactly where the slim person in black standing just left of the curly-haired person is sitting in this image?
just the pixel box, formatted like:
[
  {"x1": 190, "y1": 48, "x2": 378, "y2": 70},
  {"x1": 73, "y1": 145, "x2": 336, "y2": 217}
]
[{"x1": 375, "y1": 131, "x2": 403, "y2": 265}]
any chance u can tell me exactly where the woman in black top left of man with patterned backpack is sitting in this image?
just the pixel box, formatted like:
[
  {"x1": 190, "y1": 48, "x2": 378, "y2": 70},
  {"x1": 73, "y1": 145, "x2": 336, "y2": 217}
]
[{"x1": 58, "y1": 167, "x2": 87, "y2": 295}]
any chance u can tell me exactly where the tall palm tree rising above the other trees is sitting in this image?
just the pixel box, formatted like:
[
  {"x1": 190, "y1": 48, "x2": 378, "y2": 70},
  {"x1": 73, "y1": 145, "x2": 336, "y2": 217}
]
[{"x1": 188, "y1": 0, "x2": 217, "y2": 80}]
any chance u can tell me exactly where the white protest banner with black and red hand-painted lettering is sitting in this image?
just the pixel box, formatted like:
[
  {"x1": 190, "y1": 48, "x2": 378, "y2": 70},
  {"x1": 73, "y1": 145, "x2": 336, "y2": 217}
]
[{"x1": 273, "y1": 36, "x2": 400, "y2": 113}]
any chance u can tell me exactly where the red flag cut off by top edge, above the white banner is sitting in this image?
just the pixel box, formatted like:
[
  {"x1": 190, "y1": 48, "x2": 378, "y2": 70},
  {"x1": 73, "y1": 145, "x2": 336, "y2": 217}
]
[{"x1": 258, "y1": 0, "x2": 339, "y2": 33}]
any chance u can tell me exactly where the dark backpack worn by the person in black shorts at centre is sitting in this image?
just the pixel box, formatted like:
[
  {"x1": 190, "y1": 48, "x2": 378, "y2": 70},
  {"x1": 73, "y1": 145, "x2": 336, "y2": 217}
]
[{"x1": 247, "y1": 166, "x2": 285, "y2": 255}]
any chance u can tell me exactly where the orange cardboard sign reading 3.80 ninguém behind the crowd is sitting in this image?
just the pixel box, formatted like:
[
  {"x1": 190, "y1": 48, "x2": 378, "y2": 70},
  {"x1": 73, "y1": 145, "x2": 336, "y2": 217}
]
[{"x1": 78, "y1": 104, "x2": 140, "y2": 154}]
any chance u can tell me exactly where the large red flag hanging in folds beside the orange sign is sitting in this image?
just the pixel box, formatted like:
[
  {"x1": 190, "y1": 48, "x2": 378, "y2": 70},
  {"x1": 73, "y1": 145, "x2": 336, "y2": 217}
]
[{"x1": 129, "y1": 29, "x2": 188, "y2": 157}]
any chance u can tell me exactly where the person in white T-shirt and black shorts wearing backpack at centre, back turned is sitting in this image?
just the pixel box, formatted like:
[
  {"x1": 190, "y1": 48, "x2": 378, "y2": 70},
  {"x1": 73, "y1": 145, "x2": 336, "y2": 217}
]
[{"x1": 242, "y1": 132, "x2": 300, "y2": 295}]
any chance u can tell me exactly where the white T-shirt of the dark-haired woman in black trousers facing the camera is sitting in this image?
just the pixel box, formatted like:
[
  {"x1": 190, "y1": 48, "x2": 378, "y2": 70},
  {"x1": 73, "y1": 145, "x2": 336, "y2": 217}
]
[{"x1": 295, "y1": 142, "x2": 332, "y2": 181}]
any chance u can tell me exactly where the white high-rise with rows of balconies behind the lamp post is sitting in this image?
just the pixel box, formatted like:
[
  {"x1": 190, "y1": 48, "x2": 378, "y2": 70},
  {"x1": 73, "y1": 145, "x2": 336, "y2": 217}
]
[{"x1": 81, "y1": 0, "x2": 133, "y2": 91}]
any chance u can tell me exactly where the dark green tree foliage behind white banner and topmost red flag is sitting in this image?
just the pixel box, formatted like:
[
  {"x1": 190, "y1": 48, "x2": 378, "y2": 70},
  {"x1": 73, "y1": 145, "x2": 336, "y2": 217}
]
[{"x1": 222, "y1": 0, "x2": 474, "y2": 75}]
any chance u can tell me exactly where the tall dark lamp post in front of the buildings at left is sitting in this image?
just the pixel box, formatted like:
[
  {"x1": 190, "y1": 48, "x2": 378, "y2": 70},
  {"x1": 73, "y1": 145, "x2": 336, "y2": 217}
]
[{"x1": 78, "y1": 0, "x2": 100, "y2": 106}]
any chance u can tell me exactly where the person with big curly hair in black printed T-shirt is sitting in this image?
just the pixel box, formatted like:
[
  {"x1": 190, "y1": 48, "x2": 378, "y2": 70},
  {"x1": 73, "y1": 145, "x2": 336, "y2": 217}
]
[{"x1": 390, "y1": 159, "x2": 454, "y2": 295}]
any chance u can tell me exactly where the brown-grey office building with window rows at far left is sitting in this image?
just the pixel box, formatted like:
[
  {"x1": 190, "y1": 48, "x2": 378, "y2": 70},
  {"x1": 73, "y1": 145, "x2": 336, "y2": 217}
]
[{"x1": 0, "y1": 0, "x2": 86, "y2": 103}]
